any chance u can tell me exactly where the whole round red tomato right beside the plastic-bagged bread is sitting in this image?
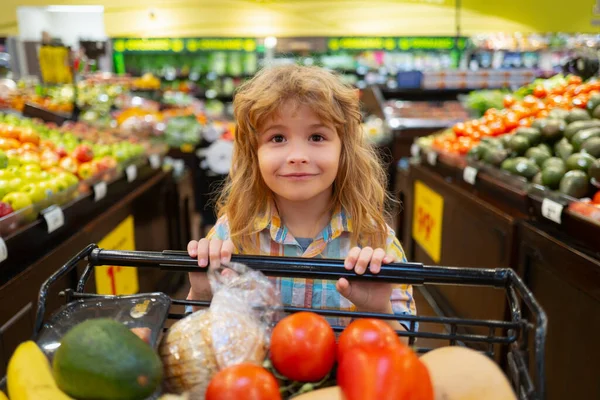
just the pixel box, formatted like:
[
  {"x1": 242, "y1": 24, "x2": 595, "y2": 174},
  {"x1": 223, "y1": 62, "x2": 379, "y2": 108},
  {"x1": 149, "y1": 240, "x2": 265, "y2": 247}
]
[{"x1": 271, "y1": 312, "x2": 335, "y2": 382}]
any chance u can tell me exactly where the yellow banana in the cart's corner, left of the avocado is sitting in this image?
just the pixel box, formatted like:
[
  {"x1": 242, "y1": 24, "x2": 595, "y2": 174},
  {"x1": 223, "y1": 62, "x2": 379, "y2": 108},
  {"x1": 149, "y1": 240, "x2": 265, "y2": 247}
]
[{"x1": 6, "y1": 341, "x2": 71, "y2": 400}]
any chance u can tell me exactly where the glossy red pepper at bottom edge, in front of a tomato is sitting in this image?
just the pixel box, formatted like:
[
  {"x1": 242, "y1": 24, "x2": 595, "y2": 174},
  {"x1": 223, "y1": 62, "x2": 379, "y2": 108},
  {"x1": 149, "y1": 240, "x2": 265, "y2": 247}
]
[{"x1": 337, "y1": 346, "x2": 433, "y2": 400}]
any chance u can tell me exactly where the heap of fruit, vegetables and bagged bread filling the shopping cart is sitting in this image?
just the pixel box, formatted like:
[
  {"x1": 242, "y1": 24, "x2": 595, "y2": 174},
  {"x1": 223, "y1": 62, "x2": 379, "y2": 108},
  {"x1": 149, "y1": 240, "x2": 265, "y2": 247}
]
[{"x1": 1, "y1": 264, "x2": 516, "y2": 400}]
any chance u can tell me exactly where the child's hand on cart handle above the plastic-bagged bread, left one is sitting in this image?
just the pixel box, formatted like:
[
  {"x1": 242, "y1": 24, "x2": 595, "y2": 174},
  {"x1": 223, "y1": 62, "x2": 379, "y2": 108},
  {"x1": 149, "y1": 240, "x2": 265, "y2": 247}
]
[{"x1": 188, "y1": 239, "x2": 234, "y2": 300}]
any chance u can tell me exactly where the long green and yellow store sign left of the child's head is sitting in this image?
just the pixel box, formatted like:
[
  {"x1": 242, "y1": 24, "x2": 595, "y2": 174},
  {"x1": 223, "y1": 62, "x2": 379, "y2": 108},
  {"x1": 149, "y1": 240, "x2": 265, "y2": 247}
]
[{"x1": 113, "y1": 38, "x2": 257, "y2": 53}]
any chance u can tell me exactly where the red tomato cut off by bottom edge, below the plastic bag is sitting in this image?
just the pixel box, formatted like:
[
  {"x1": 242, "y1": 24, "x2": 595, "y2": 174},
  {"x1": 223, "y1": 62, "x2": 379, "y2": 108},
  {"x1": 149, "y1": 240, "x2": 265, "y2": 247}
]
[{"x1": 205, "y1": 363, "x2": 281, "y2": 400}]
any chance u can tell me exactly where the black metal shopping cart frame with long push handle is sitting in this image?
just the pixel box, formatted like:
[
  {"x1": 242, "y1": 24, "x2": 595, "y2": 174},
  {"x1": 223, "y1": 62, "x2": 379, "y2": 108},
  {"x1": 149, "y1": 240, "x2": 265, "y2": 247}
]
[{"x1": 25, "y1": 244, "x2": 546, "y2": 400}]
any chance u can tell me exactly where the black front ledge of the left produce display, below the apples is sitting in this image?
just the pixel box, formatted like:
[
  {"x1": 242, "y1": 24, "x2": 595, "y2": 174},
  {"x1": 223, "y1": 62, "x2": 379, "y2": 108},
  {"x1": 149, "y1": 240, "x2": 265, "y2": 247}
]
[{"x1": 0, "y1": 159, "x2": 164, "y2": 286}]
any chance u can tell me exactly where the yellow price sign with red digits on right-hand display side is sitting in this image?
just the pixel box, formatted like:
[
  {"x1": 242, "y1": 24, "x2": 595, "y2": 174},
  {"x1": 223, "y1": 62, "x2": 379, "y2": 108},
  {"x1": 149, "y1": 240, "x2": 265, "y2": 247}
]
[{"x1": 413, "y1": 181, "x2": 444, "y2": 263}]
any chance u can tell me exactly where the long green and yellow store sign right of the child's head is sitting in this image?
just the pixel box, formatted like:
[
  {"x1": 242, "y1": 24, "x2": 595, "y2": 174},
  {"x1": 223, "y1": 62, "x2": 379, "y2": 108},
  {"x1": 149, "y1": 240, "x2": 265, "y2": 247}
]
[{"x1": 327, "y1": 36, "x2": 467, "y2": 51}]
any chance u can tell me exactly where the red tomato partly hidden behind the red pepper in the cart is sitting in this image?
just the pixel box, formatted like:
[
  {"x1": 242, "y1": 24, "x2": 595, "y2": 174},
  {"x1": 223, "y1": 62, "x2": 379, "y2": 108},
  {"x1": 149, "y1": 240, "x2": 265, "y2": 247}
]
[{"x1": 338, "y1": 318, "x2": 408, "y2": 360}]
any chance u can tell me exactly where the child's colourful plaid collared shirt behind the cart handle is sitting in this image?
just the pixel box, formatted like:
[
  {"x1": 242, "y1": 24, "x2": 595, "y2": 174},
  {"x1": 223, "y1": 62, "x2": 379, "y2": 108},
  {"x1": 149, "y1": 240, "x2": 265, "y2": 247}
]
[{"x1": 207, "y1": 205, "x2": 416, "y2": 329}]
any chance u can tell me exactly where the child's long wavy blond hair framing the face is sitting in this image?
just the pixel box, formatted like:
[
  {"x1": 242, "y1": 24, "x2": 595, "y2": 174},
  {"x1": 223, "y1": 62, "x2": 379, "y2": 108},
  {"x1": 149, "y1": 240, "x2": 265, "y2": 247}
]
[{"x1": 217, "y1": 65, "x2": 388, "y2": 254}]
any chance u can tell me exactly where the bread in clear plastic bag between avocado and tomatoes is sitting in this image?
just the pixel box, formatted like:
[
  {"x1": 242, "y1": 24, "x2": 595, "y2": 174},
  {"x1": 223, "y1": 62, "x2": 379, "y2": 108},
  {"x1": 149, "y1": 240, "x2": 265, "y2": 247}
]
[{"x1": 159, "y1": 263, "x2": 281, "y2": 400}]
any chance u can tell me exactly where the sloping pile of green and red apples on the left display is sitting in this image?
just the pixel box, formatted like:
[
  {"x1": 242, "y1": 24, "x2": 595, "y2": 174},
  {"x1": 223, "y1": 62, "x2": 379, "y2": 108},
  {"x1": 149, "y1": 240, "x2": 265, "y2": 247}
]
[{"x1": 0, "y1": 114, "x2": 144, "y2": 218}]
